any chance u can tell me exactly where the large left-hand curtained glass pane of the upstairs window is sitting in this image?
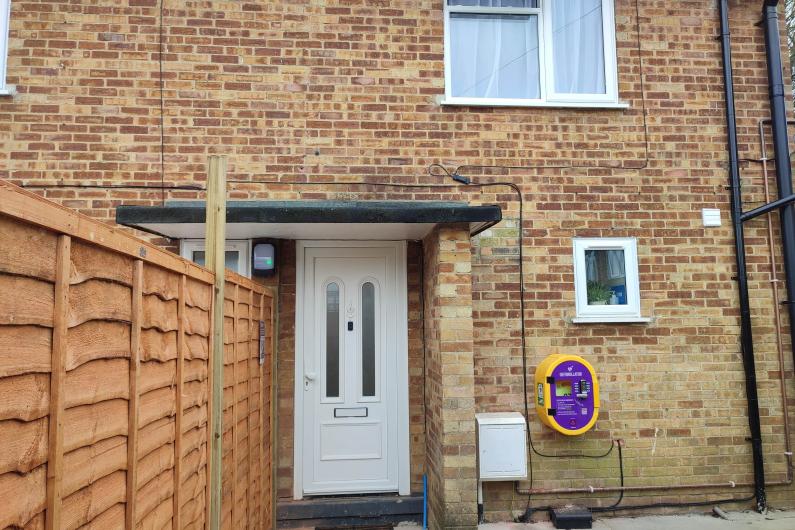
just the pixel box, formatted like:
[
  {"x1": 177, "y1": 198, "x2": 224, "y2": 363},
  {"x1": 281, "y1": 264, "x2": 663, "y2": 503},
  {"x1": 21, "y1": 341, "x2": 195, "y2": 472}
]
[{"x1": 450, "y1": 13, "x2": 541, "y2": 99}]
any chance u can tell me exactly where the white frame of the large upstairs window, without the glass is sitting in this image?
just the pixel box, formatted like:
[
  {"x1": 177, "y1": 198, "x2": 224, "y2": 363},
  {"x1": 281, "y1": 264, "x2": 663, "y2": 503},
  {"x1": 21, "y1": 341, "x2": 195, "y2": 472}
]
[{"x1": 441, "y1": 0, "x2": 629, "y2": 109}]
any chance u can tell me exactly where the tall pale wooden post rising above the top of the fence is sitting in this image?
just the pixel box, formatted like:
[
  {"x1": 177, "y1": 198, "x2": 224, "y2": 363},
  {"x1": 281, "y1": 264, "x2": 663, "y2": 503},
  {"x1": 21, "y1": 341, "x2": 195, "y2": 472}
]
[{"x1": 205, "y1": 156, "x2": 229, "y2": 530}]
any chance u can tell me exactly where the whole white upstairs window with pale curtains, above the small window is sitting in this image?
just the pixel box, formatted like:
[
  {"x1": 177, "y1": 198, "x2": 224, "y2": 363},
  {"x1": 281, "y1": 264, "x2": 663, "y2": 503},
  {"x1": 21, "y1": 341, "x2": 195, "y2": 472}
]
[{"x1": 445, "y1": 0, "x2": 619, "y2": 107}]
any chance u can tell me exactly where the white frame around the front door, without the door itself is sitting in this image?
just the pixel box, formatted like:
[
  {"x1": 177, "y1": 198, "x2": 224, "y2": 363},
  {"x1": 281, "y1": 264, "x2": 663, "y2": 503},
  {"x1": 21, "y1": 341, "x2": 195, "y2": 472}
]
[{"x1": 293, "y1": 240, "x2": 411, "y2": 499}]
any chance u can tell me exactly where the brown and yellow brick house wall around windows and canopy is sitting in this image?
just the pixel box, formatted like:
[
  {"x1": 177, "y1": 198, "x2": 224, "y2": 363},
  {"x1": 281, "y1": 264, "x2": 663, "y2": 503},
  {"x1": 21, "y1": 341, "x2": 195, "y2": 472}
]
[{"x1": 0, "y1": 0, "x2": 795, "y2": 518}]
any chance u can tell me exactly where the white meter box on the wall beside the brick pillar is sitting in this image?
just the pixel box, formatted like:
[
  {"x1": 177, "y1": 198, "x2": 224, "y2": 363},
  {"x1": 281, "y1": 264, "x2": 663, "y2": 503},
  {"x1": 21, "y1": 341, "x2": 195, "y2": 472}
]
[{"x1": 475, "y1": 412, "x2": 527, "y2": 481}]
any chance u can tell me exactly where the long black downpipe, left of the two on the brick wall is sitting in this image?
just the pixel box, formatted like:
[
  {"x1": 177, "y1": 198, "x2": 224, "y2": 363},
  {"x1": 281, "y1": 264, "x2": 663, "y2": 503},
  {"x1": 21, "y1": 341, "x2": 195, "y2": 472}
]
[{"x1": 718, "y1": 0, "x2": 767, "y2": 512}]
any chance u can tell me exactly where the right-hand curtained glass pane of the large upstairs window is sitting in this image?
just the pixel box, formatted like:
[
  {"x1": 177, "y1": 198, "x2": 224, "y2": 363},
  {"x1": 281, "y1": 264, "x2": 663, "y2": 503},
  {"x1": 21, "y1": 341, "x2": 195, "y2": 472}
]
[{"x1": 550, "y1": 0, "x2": 607, "y2": 94}]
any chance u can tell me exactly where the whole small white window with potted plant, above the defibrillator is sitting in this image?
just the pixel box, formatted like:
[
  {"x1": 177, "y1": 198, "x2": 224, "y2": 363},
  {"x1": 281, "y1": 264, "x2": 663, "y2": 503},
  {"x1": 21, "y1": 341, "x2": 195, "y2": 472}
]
[{"x1": 573, "y1": 238, "x2": 649, "y2": 323}]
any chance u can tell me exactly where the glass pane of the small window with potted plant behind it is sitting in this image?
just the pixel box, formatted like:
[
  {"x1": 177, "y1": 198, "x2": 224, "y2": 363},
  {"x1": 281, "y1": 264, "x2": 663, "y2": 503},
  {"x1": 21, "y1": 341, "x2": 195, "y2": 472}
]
[{"x1": 585, "y1": 250, "x2": 628, "y2": 305}]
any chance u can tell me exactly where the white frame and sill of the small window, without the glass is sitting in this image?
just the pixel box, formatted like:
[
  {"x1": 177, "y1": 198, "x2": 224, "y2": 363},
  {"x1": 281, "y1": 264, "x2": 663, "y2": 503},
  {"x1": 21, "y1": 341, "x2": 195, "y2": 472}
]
[{"x1": 572, "y1": 237, "x2": 651, "y2": 324}]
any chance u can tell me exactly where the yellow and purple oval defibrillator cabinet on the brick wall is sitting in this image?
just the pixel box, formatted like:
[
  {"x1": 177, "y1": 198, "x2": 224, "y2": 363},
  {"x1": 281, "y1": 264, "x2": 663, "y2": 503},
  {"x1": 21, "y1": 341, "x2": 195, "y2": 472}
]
[{"x1": 535, "y1": 353, "x2": 599, "y2": 436}]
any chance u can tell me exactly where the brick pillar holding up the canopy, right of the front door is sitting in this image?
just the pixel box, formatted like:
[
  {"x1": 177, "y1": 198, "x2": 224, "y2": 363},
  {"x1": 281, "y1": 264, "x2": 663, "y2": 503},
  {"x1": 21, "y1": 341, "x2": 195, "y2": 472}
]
[{"x1": 424, "y1": 225, "x2": 477, "y2": 529}]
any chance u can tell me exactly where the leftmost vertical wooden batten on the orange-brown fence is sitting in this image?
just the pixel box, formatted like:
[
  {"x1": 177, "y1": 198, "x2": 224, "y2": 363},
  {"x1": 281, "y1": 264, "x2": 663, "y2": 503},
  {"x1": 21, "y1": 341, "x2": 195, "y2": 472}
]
[{"x1": 45, "y1": 235, "x2": 72, "y2": 530}]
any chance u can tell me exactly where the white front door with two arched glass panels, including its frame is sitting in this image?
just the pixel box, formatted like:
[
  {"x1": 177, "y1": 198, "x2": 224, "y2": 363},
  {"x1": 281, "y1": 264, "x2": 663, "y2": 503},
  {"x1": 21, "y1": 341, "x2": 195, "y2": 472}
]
[{"x1": 296, "y1": 242, "x2": 408, "y2": 495}]
